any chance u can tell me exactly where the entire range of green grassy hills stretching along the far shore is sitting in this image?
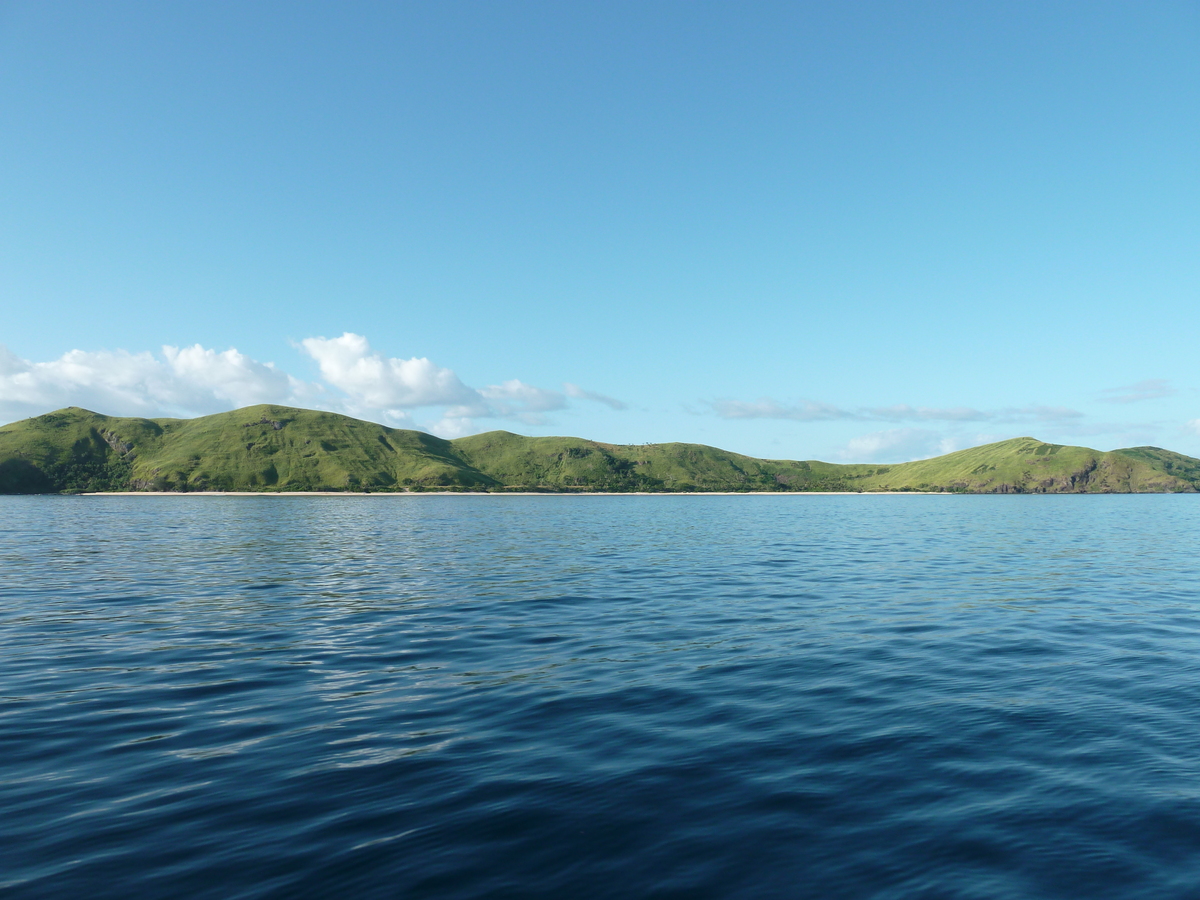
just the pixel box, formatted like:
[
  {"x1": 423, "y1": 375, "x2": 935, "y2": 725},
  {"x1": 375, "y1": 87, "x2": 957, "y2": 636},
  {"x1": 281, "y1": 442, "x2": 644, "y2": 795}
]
[{"x1": 0, "y1": 406, "x2": 1200, "y2": 493}]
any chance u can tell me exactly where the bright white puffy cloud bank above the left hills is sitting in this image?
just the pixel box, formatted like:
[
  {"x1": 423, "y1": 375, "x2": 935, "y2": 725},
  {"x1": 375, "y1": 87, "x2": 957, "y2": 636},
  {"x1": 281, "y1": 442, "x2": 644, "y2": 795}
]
[{"x1": 0, "y1": 332, "x2": 625, "y2": 437}]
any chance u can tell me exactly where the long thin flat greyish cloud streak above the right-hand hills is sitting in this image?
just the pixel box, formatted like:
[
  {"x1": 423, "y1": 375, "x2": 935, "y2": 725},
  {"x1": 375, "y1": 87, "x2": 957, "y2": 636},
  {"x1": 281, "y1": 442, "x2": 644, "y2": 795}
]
[{"x1": 709, "y1": 397, "x2": 1082, "y2": 422}]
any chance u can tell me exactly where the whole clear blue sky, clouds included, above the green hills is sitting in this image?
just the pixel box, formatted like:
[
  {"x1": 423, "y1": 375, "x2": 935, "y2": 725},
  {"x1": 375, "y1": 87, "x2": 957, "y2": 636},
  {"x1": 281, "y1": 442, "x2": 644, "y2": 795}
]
[{"x1": 0, "y1": 2, "x2": 1200, "y2": 461}]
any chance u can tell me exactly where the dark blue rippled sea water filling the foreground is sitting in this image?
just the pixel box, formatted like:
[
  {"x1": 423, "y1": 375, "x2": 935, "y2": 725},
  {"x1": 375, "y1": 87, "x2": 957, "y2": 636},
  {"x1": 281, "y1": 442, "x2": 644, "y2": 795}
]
[{"x1": 0, "y1": 496, "x2": 1200, "y2": 899}]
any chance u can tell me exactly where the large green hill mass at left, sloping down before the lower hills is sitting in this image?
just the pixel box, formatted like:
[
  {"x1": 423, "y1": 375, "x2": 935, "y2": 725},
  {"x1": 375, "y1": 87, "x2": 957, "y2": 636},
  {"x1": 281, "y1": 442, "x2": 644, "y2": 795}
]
[{"x1": 0, "y1": 406, "x2": 493, "y2": 493}]
